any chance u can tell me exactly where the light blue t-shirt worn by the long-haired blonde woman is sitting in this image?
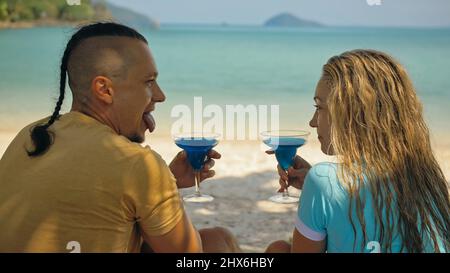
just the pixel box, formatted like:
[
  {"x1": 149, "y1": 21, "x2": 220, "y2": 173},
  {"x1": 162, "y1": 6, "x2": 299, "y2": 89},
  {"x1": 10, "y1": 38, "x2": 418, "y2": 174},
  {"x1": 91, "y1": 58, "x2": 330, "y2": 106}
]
[{"x1": 295, "y1": 163, "x2": 444, "y2": 253}]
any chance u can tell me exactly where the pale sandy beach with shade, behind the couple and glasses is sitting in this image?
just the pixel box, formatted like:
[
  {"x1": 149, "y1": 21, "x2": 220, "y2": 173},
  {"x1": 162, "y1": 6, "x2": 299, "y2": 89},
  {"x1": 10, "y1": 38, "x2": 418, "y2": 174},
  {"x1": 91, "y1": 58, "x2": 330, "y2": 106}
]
[{"x1": 0, "y1": 131, "x2": 450, "y2": 252}]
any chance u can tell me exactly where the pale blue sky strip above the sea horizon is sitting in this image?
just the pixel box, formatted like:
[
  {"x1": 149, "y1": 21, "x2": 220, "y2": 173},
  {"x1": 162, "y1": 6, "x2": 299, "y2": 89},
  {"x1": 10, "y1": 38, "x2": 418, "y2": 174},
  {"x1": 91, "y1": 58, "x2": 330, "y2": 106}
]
[{"x1": 108, "y1": 0, "x2": 450, "y2": 27}]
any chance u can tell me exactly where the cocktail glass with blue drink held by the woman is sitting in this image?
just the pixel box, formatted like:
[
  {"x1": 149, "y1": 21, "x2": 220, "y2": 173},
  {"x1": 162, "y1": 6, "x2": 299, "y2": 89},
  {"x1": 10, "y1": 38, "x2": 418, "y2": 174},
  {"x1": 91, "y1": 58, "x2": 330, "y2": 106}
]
[{"x1": 261, "y1": 130, "x2": 310, "y2": 204}]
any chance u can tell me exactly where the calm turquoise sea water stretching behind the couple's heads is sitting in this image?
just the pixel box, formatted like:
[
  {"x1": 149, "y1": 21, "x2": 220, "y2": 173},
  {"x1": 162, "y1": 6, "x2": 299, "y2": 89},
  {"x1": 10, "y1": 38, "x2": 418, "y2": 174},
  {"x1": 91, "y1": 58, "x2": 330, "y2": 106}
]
[{"x1": 0, "y1": 26, "x2": 450, "y2": 135}]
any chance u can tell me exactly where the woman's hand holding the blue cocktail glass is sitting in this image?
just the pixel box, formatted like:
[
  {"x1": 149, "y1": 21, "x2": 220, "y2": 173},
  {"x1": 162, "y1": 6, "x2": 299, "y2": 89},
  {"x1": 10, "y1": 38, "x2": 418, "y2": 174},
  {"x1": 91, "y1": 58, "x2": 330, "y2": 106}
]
[{"x1": 266, "y1": 150, "x2": 311, "y2": 192}]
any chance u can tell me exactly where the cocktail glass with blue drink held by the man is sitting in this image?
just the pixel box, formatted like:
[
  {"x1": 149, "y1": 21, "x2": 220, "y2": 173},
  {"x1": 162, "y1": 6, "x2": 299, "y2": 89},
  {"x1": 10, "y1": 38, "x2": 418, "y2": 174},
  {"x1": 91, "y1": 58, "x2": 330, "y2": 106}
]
[{"x1": 174, "y1": 133, "x2": 219, "y2": 203}]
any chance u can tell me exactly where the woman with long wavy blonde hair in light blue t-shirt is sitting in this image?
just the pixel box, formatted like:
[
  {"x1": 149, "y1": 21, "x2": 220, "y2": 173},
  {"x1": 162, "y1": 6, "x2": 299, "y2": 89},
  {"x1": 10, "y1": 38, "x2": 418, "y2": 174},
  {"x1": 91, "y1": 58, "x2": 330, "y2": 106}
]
[{"x1": 267, "y1": 50, "x2": 450, "y2": 252}]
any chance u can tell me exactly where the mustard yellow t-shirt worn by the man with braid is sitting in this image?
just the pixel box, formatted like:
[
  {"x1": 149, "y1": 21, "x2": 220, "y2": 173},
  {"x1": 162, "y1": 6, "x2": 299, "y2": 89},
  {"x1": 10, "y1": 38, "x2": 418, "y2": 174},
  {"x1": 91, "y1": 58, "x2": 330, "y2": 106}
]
[{"x1": 0, "y1": 112, "x2": 183, "y2": 252}]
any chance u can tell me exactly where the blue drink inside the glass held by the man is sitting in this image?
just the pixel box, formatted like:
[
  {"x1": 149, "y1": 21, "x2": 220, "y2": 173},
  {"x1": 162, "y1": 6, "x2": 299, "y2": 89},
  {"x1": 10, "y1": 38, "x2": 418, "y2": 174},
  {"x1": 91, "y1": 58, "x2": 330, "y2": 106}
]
[{"x1": 175, "y1": 138, "x2": 218, "y2": 171}]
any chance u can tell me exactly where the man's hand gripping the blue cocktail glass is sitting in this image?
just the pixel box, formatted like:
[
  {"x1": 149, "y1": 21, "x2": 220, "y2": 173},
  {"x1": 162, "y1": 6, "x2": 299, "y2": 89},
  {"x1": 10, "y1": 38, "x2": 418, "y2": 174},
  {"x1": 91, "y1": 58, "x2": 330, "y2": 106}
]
[{"x1": 169, "y1": 150, "x2": 222, "y2": 189}]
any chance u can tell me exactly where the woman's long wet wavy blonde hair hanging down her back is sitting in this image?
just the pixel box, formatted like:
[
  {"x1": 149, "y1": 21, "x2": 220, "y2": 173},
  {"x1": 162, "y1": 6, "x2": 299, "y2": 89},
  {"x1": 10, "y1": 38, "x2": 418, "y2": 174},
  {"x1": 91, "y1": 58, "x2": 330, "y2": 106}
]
[{"x1": 323, "y1": 50, "x2": 450, "y2": 252}]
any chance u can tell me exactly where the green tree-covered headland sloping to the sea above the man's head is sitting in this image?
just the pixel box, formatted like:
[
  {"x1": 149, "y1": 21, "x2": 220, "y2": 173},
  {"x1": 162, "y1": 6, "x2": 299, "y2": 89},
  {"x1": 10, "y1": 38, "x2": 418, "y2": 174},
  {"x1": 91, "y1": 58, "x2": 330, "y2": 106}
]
[{"x1": 0, "y1": 0, "x2": 159, "y2": 30}]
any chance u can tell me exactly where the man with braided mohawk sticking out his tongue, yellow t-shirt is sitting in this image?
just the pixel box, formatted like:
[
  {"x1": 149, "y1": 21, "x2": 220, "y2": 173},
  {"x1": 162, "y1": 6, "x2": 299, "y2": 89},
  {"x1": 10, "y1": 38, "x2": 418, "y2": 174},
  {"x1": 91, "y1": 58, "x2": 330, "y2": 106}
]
[{"x1": 0, "y1": 23, "x2": 239, "y2": 252}]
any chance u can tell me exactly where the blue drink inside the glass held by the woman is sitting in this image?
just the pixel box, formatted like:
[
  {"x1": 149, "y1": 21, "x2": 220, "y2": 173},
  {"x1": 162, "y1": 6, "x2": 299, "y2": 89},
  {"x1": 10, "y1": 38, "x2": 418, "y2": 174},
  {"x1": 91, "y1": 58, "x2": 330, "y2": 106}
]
[{"x1": 264, "y1": 137, "x2": 306, "y2": 170}]
